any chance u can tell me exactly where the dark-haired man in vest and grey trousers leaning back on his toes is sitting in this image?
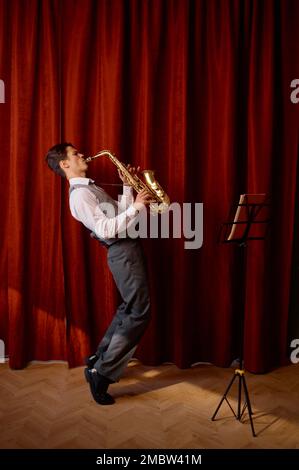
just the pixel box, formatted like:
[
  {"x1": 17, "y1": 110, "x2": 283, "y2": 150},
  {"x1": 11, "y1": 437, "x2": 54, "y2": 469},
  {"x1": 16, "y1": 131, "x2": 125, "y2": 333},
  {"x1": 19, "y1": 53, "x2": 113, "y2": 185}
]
[{"x1": 46, "y1": 143, "x2": 153, "y2": 405}]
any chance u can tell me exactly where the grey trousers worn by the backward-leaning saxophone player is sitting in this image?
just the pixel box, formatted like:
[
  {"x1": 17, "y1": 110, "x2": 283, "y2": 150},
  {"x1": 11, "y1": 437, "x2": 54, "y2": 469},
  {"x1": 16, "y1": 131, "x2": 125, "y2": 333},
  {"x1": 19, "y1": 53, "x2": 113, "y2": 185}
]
[{"x1": 94, "y1": 238, "x2": 150, "y2": 382}]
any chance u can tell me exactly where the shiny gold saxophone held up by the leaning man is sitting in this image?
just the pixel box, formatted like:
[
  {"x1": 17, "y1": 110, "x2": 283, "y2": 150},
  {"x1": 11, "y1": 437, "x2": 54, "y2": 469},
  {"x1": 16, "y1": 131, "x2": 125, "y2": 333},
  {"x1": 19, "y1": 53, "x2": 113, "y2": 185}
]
[{"x1": 85, "y1": 150, "x2": 170, "y2": 214}]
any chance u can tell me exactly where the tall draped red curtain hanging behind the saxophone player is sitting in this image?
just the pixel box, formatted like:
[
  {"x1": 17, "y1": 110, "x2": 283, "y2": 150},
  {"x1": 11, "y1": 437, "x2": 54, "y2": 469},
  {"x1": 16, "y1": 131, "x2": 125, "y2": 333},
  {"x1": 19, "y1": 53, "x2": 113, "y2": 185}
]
[{"x1": 0, "y1": 0, "x2": 299, "y2": 372}]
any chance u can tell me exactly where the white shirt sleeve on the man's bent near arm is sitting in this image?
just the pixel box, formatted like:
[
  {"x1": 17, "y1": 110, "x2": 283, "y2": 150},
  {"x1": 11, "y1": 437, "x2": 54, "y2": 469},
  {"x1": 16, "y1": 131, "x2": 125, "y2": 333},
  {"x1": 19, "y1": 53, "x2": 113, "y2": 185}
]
[{"x1": 70, "y1": 188, "x2": 138, "y2": 240}]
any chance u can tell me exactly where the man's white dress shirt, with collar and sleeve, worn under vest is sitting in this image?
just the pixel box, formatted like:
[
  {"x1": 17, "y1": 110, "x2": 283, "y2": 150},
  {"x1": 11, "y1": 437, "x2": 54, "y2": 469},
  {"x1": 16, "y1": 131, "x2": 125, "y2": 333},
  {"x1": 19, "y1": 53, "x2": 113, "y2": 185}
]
[{"x1": 69, "y1": 178, "x2": 139, "y2": 240}]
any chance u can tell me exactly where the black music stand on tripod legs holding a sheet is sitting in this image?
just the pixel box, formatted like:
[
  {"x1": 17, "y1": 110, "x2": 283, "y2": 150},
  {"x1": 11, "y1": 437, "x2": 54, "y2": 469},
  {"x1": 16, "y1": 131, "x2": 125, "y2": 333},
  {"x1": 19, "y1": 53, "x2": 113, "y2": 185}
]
[{"x1": 212, "y1": 194, "x2": 270, "y2": 437}]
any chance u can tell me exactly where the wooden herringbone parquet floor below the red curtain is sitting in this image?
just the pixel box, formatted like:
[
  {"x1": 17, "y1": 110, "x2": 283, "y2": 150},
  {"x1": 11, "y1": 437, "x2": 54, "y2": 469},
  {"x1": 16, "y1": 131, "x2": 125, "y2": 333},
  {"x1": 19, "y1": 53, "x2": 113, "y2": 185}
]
[{"x1": 0, "y1": 361, "x2": 299, "y2": 449}]
